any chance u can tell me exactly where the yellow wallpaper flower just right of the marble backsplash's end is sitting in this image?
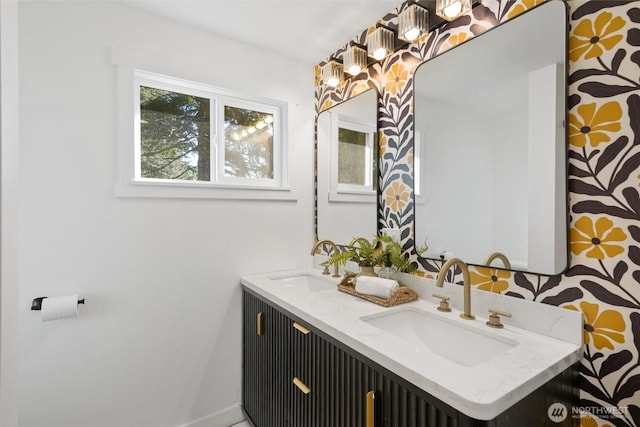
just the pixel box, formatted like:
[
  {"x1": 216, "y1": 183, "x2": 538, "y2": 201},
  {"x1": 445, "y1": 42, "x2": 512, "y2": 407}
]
[{"x1": 566, "y1": 301, "x2": 627, "y2": 350}]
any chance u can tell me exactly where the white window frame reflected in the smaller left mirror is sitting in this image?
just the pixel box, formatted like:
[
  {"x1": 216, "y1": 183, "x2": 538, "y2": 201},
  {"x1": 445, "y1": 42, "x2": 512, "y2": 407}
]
[{"x1": 329, "y1": 114, "x2": 377, "y2": 203}]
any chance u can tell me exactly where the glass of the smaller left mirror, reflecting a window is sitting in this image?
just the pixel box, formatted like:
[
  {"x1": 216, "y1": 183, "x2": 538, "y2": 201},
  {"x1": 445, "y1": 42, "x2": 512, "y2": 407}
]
[{"x1": 317, "y1": 89, "x2": 378, "y2": 244}]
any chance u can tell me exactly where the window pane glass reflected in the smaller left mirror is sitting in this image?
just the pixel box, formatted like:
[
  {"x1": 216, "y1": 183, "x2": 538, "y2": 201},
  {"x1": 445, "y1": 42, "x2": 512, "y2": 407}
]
[{"x1": 338, "y1": 128, "x2": 368, "y2": 185}]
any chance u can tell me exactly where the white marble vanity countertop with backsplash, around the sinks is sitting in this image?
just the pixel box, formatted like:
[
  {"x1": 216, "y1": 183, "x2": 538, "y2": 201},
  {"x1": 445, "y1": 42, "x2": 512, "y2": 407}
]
[{"x1": 241, "y1": 268, "x2": 582, "y2": 420}]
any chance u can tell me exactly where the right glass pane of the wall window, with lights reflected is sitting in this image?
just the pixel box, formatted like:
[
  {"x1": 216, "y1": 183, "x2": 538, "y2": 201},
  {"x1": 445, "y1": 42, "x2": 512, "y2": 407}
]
[{"x1": 224, "y1": 106, "x2": 273, "y2": 179}]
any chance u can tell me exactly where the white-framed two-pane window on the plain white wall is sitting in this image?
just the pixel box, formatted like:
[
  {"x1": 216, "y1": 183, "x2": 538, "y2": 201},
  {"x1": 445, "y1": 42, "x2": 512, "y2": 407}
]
[{"x1": 127, "y1": 71, "x2": 288, "y2": 197}]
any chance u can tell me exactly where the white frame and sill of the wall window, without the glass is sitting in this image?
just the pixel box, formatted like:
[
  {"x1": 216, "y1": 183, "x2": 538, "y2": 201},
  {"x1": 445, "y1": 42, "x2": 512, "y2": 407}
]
[{"x1": 116, "y1": 67, "x2": 297, "y2": 200}]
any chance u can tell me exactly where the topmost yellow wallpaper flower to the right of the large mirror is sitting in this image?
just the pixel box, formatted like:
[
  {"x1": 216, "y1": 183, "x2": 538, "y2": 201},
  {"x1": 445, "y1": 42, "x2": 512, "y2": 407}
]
[{"x1": 569, "y1": 12, "x2": 626, "y2": 62}]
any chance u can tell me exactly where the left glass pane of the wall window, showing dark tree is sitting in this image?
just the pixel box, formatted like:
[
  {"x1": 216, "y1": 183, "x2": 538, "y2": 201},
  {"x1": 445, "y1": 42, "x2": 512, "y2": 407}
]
[{"x1": 140, "y1": 86, "x2": 211, "y2": 181}]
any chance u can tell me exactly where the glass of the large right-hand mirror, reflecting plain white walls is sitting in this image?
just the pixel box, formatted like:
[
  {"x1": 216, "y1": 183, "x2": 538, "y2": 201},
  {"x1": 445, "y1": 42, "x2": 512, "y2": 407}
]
[{"x1": 414, "y1": 1, "x2": 568, "y2": 274}]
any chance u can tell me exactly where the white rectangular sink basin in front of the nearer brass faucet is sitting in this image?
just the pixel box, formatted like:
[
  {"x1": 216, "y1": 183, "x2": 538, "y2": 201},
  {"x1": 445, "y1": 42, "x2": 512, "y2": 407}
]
[{"x1": 360, "y1": 307, "x2": 518, "y2": 366}]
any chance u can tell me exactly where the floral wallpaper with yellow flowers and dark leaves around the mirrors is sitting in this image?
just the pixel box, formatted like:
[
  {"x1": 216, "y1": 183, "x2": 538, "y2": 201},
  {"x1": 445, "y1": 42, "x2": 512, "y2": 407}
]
[{"x1": 315, "y1": 0, "x2": 640, "y2": 427}]
